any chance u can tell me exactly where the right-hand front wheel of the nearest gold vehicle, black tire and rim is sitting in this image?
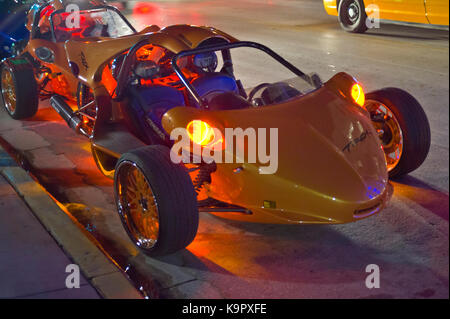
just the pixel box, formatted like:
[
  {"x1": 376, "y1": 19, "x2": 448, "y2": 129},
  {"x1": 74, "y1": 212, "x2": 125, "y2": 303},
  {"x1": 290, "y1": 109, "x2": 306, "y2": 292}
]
[{"x1": 365, "y1": 88, "x2": 431, "y2": 178}]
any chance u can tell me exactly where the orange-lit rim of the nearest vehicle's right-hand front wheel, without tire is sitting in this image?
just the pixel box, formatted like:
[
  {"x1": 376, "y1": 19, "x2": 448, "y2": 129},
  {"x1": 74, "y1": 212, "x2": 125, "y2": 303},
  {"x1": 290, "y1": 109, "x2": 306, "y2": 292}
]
[{"x1": 365, "y1": 100, "x2": 403, "y2": 172}]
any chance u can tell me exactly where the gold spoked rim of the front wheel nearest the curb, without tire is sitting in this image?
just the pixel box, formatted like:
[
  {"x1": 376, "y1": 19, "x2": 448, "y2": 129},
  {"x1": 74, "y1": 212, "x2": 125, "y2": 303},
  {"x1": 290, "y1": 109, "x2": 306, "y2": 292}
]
[{"x1": 116, "y1": 161, "x2": 159, "y2": 249}]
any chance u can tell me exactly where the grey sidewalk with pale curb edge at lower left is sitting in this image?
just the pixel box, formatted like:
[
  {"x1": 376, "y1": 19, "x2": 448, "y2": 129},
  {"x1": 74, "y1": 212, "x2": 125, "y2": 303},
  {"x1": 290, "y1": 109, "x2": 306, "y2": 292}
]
[{"x1": 0, "y1": 146, "x2": 142, "y2": 299}]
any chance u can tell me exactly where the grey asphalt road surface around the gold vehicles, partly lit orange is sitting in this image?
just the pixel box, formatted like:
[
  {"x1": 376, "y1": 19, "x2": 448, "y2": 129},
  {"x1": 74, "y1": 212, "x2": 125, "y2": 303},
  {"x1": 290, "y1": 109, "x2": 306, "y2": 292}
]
[{"x1": 0, "y1": 0, "x2": 449, "y2": 298}]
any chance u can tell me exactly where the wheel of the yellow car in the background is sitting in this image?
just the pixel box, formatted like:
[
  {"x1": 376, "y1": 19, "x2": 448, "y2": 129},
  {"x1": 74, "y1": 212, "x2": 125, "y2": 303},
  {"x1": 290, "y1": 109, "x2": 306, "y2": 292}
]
[{"x1": 338, "y1": 0, "x2": 367, "y2": 33}]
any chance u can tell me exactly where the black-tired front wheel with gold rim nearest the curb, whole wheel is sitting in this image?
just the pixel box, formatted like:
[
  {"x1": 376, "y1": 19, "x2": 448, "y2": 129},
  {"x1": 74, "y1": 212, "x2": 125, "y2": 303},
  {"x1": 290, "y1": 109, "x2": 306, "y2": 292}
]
[{"x1": 114, "y1": 145, "x2": 199, "y2": 256}]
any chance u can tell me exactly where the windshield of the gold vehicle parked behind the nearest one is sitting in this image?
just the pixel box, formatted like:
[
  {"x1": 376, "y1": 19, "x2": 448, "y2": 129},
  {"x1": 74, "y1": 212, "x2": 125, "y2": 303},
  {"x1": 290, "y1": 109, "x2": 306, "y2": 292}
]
[{"x1": 52, "y1": 8, "x2": 135, "y2": 42}]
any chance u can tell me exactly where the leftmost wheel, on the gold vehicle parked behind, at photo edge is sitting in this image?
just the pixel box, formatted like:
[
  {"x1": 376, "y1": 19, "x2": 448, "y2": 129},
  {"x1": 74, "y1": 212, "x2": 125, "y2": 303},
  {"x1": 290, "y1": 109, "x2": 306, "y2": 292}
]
[{"x1": 0, "y1": 58, "x2": 39, "y2": 120}]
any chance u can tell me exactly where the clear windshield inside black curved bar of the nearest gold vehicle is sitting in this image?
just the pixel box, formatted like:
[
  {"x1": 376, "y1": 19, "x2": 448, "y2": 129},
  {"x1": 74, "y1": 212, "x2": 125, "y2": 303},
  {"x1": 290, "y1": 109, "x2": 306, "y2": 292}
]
[{"x1": 174, "y1": 42, "x2": 321, "y2": 106}]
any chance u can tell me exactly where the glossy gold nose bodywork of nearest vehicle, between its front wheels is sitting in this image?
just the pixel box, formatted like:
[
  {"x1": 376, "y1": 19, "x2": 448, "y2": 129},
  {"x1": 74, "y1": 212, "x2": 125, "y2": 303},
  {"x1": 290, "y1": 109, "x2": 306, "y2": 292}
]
[{"x1": 163, "y1": 74, "x2": 391, "y2": 224}]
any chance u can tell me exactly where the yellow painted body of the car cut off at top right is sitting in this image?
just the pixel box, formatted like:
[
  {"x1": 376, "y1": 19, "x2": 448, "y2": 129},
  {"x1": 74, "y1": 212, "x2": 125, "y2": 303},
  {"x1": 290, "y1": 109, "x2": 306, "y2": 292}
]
[{"x1": 323, "y1": 0, "x2": 449, "y2": 26}]
